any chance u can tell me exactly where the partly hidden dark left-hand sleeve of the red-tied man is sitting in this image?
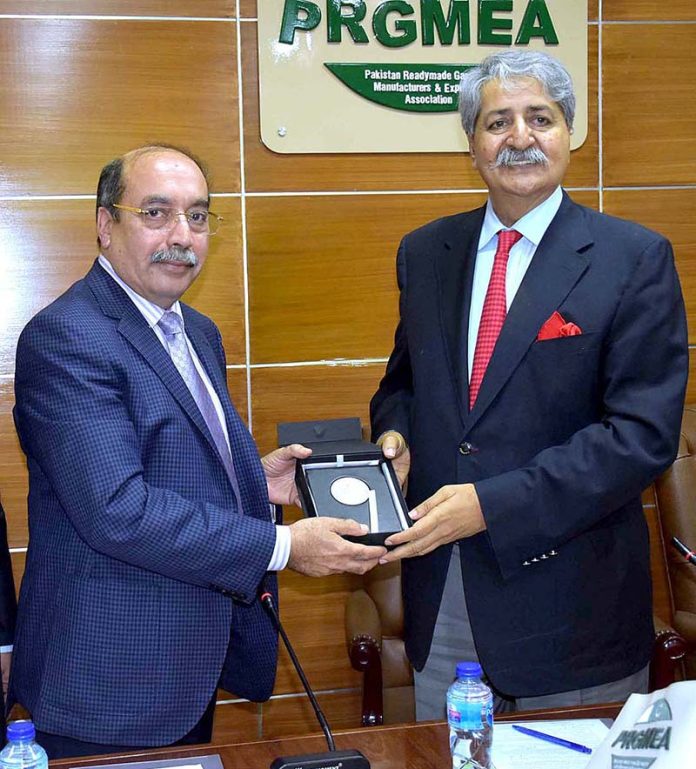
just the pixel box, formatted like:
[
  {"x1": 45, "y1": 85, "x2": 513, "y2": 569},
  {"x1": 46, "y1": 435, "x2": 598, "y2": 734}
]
[{"x1": 370, "y1": 241, "x2": 413, "y2": 442}]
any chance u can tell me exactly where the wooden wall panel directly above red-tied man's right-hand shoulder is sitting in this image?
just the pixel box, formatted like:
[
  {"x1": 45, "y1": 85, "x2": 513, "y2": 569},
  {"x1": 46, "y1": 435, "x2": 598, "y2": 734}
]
[{"x1": 604, "y1": 189, "x2": 696, "y2": 344}]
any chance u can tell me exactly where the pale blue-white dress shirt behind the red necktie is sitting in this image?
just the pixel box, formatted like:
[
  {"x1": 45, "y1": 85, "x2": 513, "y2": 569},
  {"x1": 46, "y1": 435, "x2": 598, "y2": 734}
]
[{"x1": 467, "y1": 187, "x2": 563, "y2": 381}]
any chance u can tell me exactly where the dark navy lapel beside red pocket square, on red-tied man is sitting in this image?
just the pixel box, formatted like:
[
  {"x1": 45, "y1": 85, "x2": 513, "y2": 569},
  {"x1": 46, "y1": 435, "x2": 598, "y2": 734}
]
[{"x1": 466, "y1": 193, "x2": 592, "y2": 429}]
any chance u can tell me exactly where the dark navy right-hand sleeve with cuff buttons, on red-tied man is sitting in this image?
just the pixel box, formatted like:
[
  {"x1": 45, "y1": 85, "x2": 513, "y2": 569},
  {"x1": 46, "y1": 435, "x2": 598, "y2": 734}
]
[{"x1": 475, "y1": 236, "x2": 688, "y2": 576}]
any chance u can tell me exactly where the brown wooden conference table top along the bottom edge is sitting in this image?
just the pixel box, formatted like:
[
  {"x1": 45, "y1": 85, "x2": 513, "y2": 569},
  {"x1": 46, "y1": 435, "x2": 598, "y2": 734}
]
[{"x1": 51, "y1": 704, "x2": 621, "y2": 769}]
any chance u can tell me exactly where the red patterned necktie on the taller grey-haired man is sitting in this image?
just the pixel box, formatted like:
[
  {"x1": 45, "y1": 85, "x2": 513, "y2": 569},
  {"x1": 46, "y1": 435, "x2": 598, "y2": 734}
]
[{"x1": 469, "y1": 230, "x2": 522, "y2": 410}]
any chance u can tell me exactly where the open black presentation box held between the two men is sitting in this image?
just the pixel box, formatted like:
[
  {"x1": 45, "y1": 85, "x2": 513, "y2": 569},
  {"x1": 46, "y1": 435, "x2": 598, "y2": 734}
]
[{"x1": 278, "y1": 417, "x2": 410, "y2": 545}]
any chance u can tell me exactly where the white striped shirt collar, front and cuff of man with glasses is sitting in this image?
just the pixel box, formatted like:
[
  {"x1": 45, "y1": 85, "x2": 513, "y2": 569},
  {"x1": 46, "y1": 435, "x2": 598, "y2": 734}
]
[{"x1": 99, "y1": 254, "x2": 290, "y2": 571}]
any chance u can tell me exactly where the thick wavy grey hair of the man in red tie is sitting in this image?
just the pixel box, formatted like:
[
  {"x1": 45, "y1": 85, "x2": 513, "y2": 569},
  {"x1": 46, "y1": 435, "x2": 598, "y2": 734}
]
[{"x1": 459, "y1": 49, "x2": 575, "y2": 136}]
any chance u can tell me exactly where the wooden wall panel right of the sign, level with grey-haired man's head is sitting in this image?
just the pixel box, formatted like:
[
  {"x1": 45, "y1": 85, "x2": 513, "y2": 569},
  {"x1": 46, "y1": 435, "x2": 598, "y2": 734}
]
[{"x1": 603, "y1": 24, "x2": 696, "y2": 186}]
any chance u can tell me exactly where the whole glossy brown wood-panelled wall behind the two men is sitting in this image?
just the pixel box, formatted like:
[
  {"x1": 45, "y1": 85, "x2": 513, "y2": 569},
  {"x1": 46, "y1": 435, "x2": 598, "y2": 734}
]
[{"x1": 0, "y1": 0, "x2": 696, "y2": 739}]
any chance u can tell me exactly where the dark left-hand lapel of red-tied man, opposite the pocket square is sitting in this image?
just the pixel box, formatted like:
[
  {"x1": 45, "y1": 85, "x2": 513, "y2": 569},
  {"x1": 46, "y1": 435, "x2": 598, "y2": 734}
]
[{"x1": 435, "y1": 206, "x2": 485, "y2": 420}]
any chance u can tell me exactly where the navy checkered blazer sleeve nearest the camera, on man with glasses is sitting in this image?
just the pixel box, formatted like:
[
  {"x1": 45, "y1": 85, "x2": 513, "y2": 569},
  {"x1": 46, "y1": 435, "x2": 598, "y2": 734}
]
[{"x1": 15, "y1": 314, "x2": 275, "y2": 602}]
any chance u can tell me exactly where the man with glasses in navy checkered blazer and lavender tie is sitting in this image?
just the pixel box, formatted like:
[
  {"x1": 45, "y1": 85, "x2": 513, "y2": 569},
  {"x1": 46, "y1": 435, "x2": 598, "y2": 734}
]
[{"x1": 10, "y1": 145, "x2": 385, "y2": 758}]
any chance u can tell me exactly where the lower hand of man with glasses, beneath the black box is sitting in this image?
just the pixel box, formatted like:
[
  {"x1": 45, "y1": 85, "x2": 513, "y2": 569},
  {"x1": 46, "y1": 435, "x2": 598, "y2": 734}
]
[{"x1": 288, "y1": 518, "x2": 387, "y2": 577}]
